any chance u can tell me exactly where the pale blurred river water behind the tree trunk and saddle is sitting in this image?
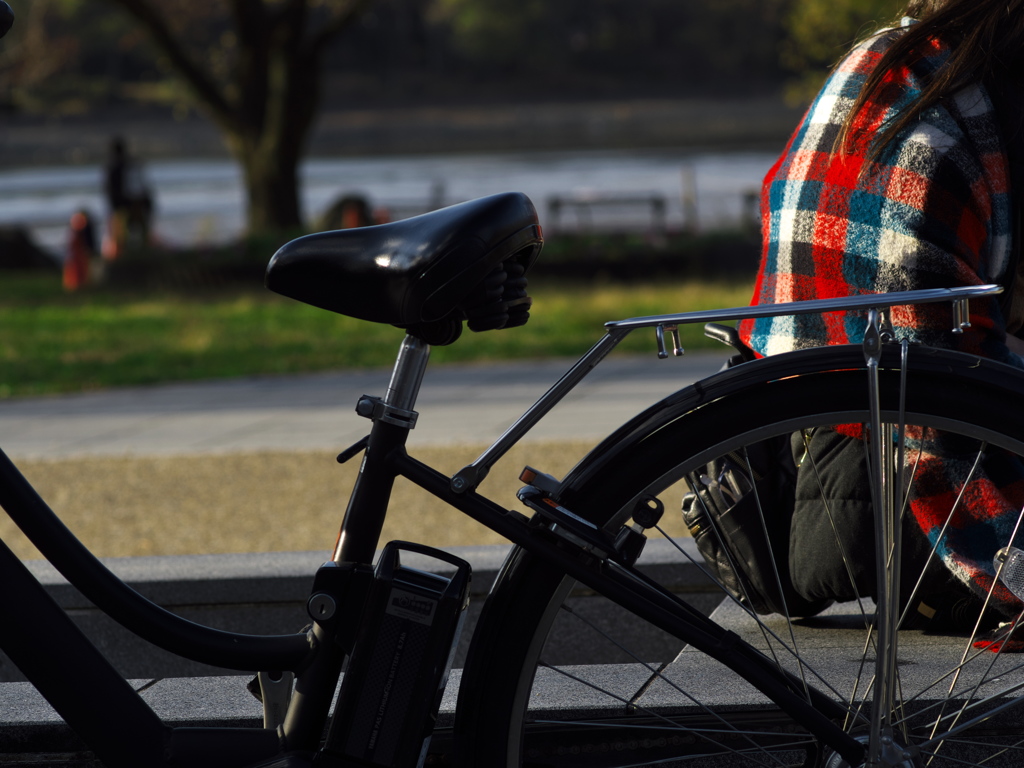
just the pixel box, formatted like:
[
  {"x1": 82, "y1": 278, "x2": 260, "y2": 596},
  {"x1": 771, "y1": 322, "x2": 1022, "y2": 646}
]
[{"x1": 0, "y1": 151, "x2": 774, "y2": 255}]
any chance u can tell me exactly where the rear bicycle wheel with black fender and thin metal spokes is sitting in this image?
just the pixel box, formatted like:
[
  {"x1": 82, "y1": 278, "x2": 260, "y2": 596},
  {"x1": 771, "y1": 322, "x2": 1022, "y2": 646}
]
[{"x1": 457, "y1": 348, "x2": 1024, "y2": 768}]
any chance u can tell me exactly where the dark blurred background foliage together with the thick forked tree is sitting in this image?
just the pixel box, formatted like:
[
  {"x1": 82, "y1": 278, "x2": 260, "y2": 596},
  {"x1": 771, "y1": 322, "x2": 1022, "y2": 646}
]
[{"x1": 0, "y1": 0, "x2": 913, "y2": 234}]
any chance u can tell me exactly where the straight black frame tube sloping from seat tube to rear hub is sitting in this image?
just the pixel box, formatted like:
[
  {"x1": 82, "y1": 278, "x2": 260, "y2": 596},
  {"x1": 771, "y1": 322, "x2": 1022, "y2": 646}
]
[{"x1": 390, "y1": 451, "x2": 864, "y2": 765}]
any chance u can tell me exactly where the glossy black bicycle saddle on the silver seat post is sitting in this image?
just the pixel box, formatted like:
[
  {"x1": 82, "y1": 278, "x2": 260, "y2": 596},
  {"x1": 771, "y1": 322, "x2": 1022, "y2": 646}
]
[{"x1": 265, "y1": 193, "x2": 544, "y2": 344}]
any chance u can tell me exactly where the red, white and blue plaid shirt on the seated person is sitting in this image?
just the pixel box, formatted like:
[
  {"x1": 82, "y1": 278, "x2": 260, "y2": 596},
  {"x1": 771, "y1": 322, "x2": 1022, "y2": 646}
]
[{"x1": 740, "y1": 19, "x2": 1024, "y2": 615}]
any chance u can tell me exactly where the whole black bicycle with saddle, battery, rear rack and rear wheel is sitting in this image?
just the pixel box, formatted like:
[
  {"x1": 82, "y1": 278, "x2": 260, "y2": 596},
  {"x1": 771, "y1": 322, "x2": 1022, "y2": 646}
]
[{"x1": 0, "y1": 186, "x2": 1024, "y2": 768}]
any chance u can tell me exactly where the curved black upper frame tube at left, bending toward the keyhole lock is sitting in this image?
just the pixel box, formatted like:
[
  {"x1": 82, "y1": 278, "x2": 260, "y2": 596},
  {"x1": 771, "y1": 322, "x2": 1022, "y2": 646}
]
[{"x1": 0, "y1": 451, "x2": 311, "y2": 671}]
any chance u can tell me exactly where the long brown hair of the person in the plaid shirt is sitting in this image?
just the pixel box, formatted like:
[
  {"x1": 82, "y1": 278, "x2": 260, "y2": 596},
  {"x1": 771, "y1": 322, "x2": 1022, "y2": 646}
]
[{"x1": 837, "y1": 0, "x2": 1024, "y2": 158}]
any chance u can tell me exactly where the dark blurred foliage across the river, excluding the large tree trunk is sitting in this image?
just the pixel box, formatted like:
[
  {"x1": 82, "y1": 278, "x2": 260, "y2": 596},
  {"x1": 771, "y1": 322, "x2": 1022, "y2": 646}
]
[{"x1": 0, "y1": 0, "x2": 900, "y2": 117}]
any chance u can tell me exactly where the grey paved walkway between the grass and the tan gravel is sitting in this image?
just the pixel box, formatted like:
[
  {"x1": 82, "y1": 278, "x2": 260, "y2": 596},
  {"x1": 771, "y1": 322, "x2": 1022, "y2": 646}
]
[{"x1": 0, "y1": 351, "x2": 726, "y2": 458}]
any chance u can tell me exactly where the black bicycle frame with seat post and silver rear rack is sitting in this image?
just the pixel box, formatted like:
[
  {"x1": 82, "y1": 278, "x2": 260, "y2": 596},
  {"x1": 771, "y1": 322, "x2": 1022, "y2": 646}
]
[{"x1": 0, "y1": 286, "x2": 1001, "y2": 768}]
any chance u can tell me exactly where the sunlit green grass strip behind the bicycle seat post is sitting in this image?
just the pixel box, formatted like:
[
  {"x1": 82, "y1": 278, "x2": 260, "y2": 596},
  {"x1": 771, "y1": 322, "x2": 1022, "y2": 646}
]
[{"x1": 0, "y1": 272, "x2": 751, "y2": 397}]
